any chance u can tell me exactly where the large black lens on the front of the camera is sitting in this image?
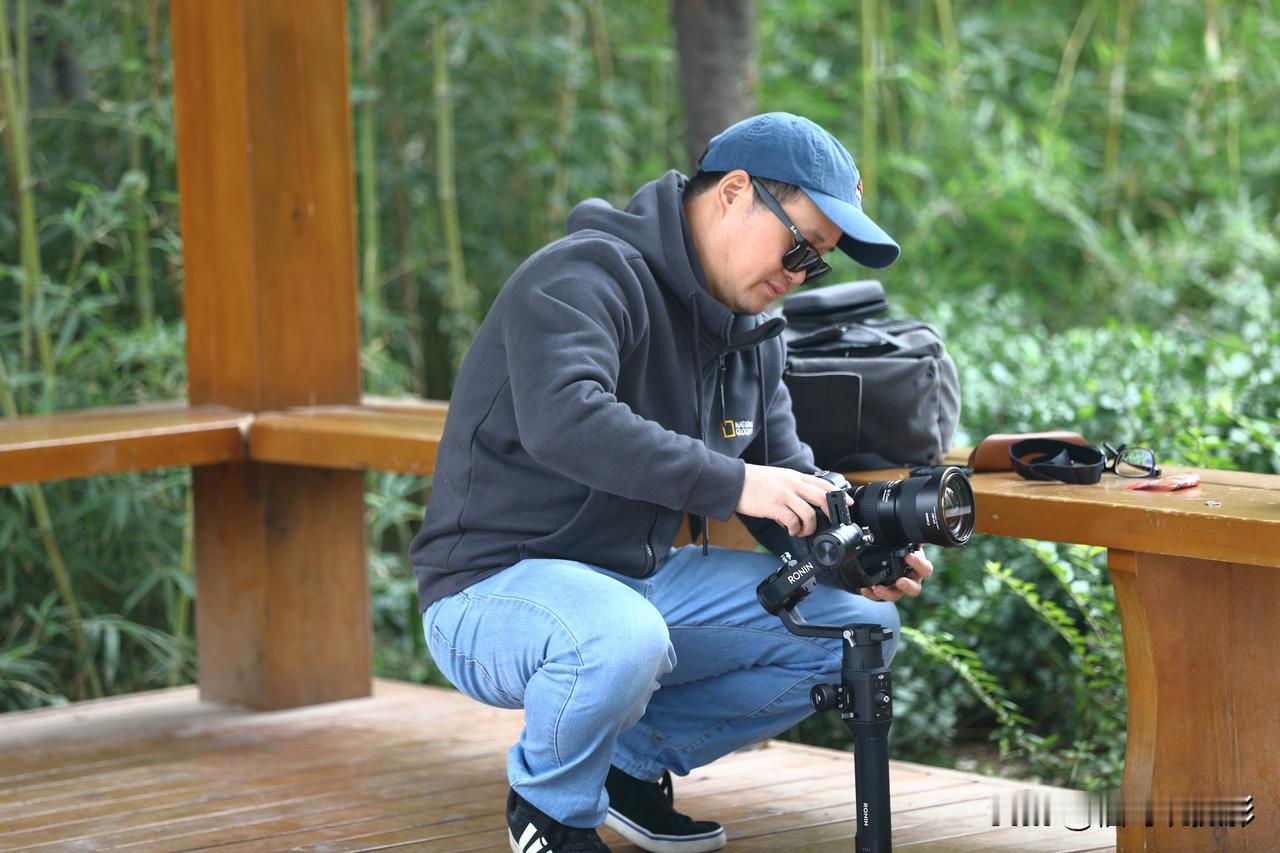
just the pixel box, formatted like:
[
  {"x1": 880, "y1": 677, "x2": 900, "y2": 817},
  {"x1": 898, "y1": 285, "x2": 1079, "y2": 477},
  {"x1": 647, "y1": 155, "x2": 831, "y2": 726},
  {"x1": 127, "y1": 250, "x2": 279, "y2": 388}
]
[{"x1": 854, "y1": 467, "x2": 974, "y2": 548}]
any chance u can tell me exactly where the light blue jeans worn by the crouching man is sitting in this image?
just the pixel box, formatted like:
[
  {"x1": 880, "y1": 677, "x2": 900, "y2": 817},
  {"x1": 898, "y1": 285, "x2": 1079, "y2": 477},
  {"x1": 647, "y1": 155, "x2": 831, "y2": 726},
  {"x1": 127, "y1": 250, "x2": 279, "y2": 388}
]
[{"x1": 422, "y1": 546, "x2": 899, "y2": 827}]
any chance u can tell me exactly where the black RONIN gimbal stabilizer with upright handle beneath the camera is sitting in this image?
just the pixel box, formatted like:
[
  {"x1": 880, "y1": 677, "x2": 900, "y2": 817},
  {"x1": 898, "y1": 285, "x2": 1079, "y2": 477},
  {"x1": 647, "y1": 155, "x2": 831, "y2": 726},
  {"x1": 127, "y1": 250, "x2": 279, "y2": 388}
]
[{"x1": 755, "y1": 537, "x2": 893, "y2": 853}]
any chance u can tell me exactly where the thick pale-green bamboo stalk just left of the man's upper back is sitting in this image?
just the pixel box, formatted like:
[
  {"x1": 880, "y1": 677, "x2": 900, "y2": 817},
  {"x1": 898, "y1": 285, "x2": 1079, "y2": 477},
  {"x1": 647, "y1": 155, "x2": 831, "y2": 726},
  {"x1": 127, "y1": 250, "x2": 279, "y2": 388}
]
[{"x1": 431, "y1": 15, "x2": 476, "y2": 384}]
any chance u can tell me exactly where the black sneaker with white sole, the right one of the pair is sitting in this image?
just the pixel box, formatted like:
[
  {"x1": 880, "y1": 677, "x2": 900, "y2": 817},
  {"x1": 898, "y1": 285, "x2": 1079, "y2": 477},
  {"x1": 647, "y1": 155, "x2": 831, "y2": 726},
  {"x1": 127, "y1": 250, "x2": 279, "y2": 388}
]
[{"x1": 604, "y1": 767, "x2": 724, "y2": 853}]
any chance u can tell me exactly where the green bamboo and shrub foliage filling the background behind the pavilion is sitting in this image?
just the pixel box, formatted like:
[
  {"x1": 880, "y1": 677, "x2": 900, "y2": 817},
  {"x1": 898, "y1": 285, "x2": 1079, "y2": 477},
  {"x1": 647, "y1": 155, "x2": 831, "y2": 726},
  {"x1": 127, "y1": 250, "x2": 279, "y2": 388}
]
[{"x1": 0, "y1": 0, "x2": 1280, "y2": 786}]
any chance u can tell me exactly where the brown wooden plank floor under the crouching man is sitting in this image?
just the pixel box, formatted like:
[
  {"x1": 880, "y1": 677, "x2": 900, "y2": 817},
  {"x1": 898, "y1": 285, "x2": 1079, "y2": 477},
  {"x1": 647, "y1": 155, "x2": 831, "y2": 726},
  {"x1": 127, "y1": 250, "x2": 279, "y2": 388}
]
[{"x1": 0, "y1": 680, "x2": 1115, "y2": 853}]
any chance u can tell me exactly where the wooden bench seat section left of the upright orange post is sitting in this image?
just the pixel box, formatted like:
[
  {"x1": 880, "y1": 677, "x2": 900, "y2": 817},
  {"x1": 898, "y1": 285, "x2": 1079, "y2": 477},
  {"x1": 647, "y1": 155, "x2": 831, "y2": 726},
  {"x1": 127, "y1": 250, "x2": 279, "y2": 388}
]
[{"x1": 0, "y1": 403, "x2": 250, "y2": 485}]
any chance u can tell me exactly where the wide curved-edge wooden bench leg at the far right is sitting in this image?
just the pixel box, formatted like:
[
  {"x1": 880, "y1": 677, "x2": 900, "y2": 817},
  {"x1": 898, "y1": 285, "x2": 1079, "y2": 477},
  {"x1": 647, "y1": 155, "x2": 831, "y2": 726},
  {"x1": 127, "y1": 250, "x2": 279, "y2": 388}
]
[{"x1": 1107, "y1": 549, "x2": 1280, "y2": 853}]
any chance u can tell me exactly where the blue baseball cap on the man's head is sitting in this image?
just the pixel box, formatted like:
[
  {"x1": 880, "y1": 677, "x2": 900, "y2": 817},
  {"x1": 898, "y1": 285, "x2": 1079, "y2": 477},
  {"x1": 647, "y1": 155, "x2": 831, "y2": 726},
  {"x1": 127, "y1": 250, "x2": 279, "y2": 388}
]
[{"x1": 698, "y1": 113, "x2": 902, "y2": 269}]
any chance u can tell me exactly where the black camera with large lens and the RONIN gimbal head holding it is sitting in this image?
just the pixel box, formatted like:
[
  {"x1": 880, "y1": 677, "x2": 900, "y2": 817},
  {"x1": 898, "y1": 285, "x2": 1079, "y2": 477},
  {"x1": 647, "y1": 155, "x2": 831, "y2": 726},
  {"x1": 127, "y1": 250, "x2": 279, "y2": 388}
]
[{"x1": 756, "y1": 466, "x2": 974, "y2": 615}]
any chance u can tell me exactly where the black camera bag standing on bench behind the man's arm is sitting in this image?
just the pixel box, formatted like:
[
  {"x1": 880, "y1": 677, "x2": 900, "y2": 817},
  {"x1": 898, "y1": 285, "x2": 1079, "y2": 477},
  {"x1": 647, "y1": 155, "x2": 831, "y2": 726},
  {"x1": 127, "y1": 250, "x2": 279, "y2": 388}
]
[{"x1": 782, "y1": 282, "x2": 960, "y2": 471}]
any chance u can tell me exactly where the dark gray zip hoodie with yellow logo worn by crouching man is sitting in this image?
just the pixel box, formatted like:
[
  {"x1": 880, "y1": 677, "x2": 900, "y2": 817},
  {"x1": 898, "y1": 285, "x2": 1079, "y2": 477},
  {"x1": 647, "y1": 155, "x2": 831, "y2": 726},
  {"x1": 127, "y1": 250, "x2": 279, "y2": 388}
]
[{"x1": 410, "y1": 172, "x2": 814, "y2": 611}]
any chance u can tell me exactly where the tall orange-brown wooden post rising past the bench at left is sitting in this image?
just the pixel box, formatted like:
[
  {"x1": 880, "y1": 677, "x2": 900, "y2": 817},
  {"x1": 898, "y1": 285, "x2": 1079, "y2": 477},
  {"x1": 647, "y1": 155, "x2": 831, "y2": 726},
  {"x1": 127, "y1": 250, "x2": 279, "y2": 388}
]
[{"x1": 172, "y1": 0, "x2": 371, "y2": 708}]
